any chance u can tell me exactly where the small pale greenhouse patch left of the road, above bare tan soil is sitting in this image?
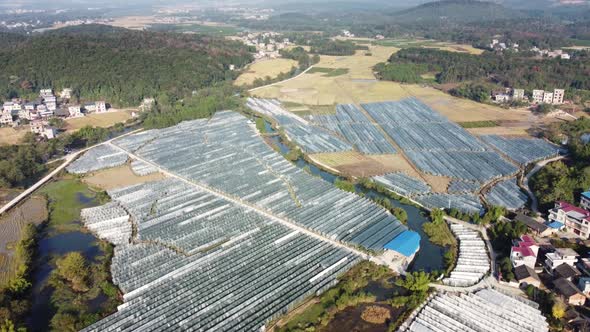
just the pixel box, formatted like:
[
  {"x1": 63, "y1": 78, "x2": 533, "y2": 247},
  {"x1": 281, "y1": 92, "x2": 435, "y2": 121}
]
[{"x1": 66, "y1": 144, "x2": 127, "y2": 174}]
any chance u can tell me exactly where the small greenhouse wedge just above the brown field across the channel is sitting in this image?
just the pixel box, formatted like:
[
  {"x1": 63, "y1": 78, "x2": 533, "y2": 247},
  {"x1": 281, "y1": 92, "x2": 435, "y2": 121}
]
[{"x1": 310, "y1": 104, "x2": 396, "y2": 154}]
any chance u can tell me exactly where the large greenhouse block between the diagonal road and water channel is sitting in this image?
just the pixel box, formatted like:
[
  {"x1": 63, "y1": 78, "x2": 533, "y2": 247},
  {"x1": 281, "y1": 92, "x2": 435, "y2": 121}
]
[{"x1": 110, "y1": 112, "x2": 416, "y2": 251}]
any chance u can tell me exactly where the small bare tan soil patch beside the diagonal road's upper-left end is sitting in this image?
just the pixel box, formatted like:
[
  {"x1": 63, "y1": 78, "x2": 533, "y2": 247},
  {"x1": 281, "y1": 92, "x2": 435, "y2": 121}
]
[{"x1": 82, "y1": 165, "x2": 165, "y2": 190}]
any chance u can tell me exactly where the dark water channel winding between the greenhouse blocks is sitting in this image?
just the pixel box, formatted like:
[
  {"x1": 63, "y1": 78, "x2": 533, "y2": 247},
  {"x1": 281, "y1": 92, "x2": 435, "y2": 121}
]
[{"x1": 264, "y1": 120, "x2": 446, "y2": 272}]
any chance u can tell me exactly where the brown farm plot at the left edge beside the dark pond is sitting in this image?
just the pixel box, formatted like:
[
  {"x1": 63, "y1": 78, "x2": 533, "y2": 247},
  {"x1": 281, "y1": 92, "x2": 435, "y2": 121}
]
[{"x1": 0, "y1": 196, "x2": 48, "y2": 287}]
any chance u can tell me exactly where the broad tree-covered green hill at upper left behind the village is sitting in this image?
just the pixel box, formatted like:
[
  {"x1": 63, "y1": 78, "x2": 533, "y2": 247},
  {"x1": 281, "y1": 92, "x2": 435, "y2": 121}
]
[{"x1": 0, "y1": 25, "x2": 251, "y2": 106}]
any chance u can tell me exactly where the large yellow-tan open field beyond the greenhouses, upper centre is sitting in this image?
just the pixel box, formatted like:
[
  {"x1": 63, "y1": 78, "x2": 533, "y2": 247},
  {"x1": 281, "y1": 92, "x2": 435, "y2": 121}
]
[{"x1": 252, "y1": 45, "x2": 536, "y2": 122}]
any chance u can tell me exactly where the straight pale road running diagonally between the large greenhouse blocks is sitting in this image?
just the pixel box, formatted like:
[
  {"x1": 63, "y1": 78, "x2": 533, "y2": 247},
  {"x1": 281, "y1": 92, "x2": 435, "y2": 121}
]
[{"x1": 109, "y1": 142, "x2": 380, "y2": 265}]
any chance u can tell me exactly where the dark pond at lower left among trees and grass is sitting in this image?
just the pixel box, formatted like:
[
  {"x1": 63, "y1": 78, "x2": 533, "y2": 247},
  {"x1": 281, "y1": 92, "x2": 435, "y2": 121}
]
[{"x1": 27, "y1": 192, "x2": 106, "y2": 331}]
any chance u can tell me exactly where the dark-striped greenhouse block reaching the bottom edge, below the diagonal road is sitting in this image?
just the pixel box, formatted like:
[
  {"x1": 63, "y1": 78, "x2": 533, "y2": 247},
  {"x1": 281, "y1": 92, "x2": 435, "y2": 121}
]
[{"x1": 83, "y1": 218, "x2": 359, "y2": 332}]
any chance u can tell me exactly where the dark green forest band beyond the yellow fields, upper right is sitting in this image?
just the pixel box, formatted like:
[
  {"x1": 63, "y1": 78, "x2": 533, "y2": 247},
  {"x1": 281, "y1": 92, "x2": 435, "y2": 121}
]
[{"x1": 375, "y1": 48, "x2": 590, "y2": 99}]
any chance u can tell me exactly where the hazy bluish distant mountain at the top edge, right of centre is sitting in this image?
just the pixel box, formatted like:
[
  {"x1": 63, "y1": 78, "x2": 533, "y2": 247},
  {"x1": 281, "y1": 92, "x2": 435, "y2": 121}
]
[{"x1": 391, "y1": 0, "x2": 528, "y2": 23}]
